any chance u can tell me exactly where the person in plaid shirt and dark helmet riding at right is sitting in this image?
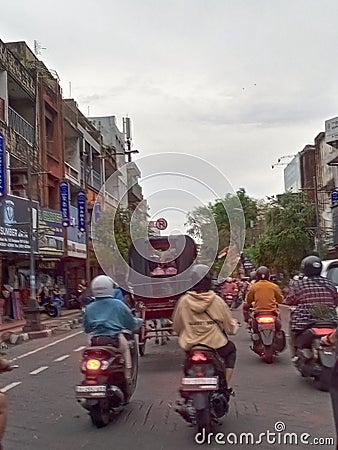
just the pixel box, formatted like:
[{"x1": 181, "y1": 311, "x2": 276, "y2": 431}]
[{"x1": 285, "y1": 255, "x2": 338, "y2": 357}]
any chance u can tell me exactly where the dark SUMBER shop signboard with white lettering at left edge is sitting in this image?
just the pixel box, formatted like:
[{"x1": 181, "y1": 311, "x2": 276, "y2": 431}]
[{"x1": 0, "y1": 195, "x2": 38, "y2": 253}]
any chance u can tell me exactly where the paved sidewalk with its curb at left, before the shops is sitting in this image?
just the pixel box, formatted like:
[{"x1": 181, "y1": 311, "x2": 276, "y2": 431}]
[{"x1": 0, "y1": 309, "x2": 82, "y2": 348}]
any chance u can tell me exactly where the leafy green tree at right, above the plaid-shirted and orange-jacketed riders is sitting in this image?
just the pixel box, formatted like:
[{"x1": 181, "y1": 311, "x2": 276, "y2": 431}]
[{"x1": 248, "y1": 192, "x2": 315, "y2": 276}]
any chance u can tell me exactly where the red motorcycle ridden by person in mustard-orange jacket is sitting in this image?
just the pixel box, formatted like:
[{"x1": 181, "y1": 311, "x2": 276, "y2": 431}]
[{"x1": 250, "y1": 311, "x2": 286, "y2": 364}]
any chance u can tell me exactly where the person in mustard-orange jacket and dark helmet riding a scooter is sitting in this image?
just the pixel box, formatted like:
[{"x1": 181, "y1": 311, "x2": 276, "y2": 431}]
[{"x1": 243, "y1": 266, "x2": 283, "y2": 333}]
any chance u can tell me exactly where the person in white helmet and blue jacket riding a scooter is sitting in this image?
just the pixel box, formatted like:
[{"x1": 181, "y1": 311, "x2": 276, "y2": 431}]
[{"x1": 83, "y1": 275, "x2": 143, "y2": 379}]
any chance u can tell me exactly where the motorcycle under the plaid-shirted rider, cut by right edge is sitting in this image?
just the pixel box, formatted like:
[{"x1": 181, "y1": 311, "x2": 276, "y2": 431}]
[{"x1": 293, "y1": 320, "x2": 337, "y2": 392}]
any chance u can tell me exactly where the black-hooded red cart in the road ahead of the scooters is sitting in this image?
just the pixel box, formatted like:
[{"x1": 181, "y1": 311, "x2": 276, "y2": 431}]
[{"x1": 128, "y1": 235, "x2": 197, "y2": 356}]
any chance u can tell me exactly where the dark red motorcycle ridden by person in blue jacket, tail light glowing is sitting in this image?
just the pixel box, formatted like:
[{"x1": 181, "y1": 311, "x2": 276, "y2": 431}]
[{"x1": 75, "y1": 331, "x2": 138, "y2": 428}]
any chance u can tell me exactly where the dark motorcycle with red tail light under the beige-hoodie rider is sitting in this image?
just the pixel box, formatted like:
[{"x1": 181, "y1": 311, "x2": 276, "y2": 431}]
[{"x1": 175, "y1": 345, "x2": 231, "y2": 440}]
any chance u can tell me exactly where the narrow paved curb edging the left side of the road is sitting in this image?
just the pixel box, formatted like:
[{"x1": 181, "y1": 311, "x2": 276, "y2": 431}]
[{"x1": 0, "y1": 317, "x2": 82, "y2": 349}]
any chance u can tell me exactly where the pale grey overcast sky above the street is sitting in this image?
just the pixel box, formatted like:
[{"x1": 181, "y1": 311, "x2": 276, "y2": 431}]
[{"x1": 0, "y1": 0, "x2": 338, "y2": 230}]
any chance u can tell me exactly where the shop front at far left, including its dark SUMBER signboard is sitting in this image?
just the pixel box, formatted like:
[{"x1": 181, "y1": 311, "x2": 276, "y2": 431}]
[{"x1": 0, "y1": 195, "x2": 38, "y2": 320}]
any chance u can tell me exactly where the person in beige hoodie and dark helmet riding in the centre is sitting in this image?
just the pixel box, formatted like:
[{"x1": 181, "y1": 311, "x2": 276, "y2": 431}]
[{"x1": 172, "y1": 264, "x2": 238, "y2": 386}]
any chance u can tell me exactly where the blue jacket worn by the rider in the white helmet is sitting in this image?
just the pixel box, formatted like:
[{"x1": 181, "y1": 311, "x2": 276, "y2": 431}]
[{"x1": 83, "y1": 297, "x2": 142, "y2": 337}]
